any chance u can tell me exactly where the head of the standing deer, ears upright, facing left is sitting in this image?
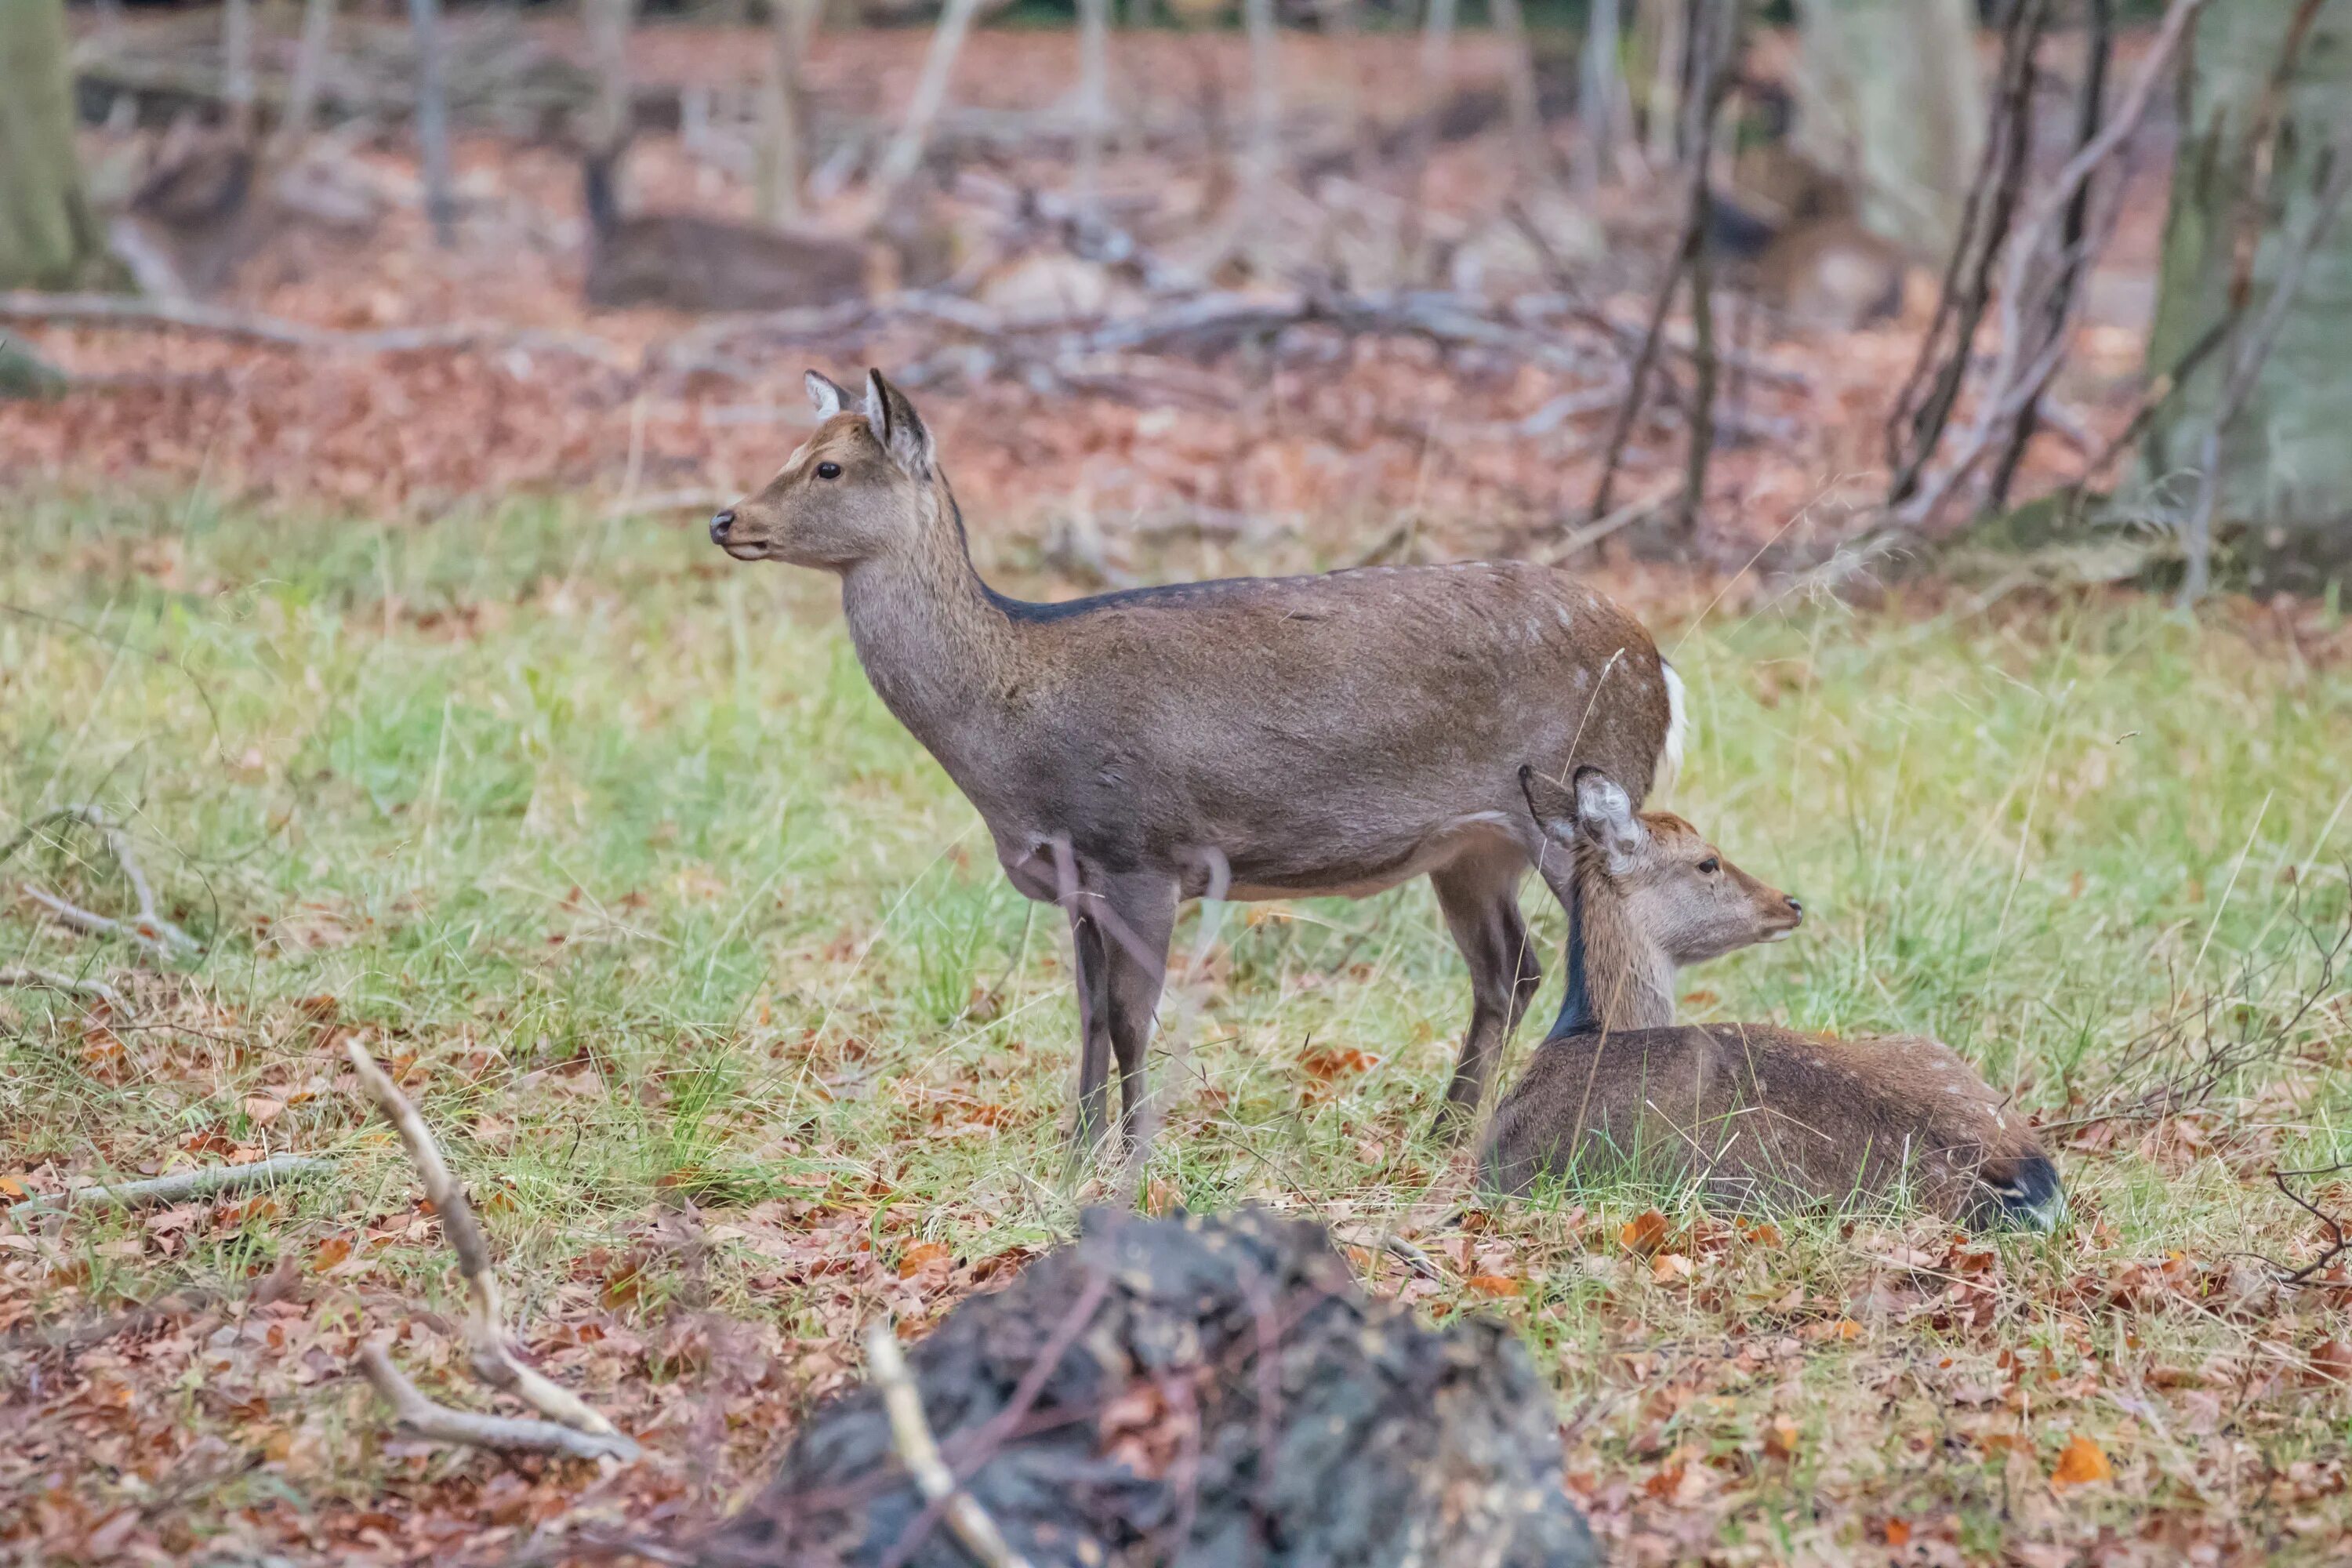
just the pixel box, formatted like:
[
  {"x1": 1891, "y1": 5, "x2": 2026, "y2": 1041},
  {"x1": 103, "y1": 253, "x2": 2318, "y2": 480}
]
[{"x1": 710, "y1": 369, "x2": 938, "y2": 572}]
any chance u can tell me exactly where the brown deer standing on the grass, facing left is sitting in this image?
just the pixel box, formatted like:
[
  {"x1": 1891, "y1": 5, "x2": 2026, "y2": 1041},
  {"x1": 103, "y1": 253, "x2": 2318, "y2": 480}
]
[{"x1": 710, "y1": 372, "x2": 1686, "y2": 1147}]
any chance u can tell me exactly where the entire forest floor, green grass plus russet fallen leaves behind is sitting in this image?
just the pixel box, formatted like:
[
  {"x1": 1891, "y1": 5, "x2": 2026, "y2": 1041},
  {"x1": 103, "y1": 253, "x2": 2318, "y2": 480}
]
[{"x1": 0, "y1": 12, "x2": 2352, "y2": 1568}]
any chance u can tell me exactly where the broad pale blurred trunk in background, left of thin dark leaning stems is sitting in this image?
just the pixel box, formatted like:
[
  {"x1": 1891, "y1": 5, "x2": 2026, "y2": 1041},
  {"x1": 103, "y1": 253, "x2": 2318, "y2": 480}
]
[{"x1": 1797, "y1": 0, "x2": 1985, "y2": 259}]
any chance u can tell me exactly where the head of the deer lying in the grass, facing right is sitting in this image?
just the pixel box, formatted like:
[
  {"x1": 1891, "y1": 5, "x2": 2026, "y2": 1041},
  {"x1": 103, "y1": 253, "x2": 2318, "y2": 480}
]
[{"x1": 1519, "y1": 767, "x2": 1804, "y2": 968}]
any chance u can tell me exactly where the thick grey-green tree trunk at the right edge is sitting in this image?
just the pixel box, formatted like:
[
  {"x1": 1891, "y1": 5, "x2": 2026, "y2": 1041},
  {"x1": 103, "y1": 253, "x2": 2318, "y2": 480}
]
[{"x1": 2140, "y1": 5, "x2": 2352, "y2": 588}]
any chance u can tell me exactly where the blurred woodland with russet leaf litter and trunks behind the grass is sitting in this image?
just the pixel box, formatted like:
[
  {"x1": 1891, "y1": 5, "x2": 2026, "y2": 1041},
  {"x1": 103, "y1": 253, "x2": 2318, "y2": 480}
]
[{"x1": 0, "y1": 0, "x2": 2352, "y2": 595}]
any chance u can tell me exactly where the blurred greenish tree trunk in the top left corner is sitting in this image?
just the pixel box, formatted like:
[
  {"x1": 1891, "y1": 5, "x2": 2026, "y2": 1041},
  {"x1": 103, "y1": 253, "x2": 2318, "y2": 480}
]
[{"x1": 0, "y1": 0, "x2": 111, "y2": 289}]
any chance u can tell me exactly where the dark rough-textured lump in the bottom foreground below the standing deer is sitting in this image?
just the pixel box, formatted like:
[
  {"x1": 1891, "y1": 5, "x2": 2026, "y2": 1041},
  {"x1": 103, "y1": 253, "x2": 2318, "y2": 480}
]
[{"x1": 696, "y1": 1210, "x2": 1599, "y2": 1568}]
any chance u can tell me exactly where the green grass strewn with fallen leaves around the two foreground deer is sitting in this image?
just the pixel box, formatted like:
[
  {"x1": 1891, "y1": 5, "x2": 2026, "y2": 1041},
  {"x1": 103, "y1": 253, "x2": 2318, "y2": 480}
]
[{"x1": 0, "y1": 503, "x2": 2352, "y2": 1563}]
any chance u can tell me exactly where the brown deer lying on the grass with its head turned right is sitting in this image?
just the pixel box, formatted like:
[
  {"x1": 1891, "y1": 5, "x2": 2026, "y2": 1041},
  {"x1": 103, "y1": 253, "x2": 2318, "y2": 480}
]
[{"x1": 1486, "y1": 767, "x2": 2065, "y2": 1229}]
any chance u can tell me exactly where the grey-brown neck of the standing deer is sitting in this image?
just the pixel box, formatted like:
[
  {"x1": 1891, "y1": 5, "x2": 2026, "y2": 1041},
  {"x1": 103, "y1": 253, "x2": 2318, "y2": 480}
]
[{"x1": 842, "y1": 480, "x2": 1014, "y2": 761}]
